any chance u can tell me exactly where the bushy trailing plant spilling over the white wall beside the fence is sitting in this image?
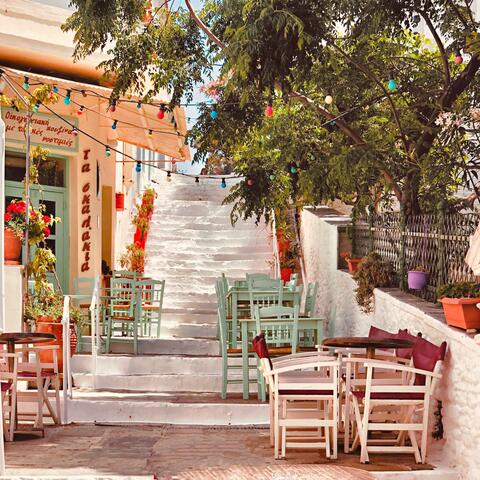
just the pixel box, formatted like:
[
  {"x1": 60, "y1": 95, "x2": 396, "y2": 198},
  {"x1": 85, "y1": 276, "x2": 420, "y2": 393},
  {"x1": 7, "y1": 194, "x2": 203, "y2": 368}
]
[{"x1": 353, "y1": 253, "x2": 395, "y2": 313}]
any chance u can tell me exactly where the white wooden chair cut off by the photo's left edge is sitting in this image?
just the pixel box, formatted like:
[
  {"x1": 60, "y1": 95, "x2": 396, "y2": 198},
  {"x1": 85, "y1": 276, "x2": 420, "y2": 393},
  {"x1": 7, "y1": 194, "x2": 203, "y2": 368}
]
[{"x1": 0, "y1": 351, "x2": 21, "y2": 442}]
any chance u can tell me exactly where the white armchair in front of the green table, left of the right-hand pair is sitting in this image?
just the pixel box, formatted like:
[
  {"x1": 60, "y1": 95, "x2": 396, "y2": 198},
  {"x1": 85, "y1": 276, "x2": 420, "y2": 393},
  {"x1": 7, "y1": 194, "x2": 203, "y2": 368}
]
[{"x1": 253, "y1": 334, "x2": 340, "y2": 459}]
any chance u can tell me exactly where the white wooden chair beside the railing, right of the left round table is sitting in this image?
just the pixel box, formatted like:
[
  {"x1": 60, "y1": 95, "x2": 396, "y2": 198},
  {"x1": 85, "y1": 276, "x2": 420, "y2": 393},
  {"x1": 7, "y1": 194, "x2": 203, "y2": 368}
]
[{"x1": 17, "y1": 345, "x2": 61, "y2": 430}]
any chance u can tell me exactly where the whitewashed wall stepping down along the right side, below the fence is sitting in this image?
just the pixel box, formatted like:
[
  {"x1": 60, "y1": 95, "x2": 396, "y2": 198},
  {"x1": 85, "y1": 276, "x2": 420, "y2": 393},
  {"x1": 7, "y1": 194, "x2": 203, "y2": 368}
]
[{"x1": 301, "y1": 208, "x2": 480, "y2": 480}]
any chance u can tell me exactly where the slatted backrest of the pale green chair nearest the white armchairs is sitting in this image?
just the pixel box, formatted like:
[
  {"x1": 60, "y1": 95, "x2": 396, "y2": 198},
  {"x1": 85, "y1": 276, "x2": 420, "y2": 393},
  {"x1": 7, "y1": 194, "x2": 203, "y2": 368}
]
[{"x1": 254, "y1": 305, "x2": 298, "y2": 352}]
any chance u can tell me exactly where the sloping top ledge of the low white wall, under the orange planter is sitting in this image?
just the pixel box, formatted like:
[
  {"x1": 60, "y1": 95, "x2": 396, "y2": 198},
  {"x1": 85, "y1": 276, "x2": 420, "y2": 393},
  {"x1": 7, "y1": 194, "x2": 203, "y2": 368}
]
[{"x1": 338, "y1": 270, "x2": 480, "y2": 354}]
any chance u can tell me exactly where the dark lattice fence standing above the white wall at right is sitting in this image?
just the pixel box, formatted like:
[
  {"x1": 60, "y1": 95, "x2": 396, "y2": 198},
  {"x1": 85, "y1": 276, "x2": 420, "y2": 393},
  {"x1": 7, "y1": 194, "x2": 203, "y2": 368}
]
[{"x1": 352, "y1": 211, "x2": 480, "y2": 302}]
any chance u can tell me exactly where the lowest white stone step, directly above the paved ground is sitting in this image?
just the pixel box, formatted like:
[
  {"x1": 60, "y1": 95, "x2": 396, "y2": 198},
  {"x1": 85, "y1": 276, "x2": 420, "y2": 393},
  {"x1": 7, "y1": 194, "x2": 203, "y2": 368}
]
[{"x1": 68, "y1": 390, "x2": 269, "y2": 425}]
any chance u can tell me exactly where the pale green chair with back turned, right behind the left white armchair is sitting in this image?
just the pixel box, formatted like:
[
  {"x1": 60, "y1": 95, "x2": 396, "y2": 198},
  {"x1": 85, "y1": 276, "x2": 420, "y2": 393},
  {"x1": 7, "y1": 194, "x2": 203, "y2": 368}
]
[{"x1": 254, "y1": 305, "x2": 298, "y2": 402}]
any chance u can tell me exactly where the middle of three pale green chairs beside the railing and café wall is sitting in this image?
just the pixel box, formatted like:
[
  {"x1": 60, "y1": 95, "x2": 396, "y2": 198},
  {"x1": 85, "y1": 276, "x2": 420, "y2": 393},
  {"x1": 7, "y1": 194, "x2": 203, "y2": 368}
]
[{"x1": 106, "y1": 278, "x2": 142, "y2": 355}]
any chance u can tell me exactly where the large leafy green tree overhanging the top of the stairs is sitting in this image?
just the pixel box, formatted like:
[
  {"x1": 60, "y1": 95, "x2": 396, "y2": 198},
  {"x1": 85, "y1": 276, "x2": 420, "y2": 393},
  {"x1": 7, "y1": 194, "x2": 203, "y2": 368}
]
[{"x1": 65, "y1": 0, "x2": 480, "y2": 219}]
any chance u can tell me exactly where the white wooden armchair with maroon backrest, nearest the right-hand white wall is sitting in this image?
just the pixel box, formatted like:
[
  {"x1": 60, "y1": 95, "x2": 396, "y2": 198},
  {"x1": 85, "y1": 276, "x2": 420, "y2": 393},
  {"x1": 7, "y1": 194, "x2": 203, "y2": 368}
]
[{"x1": 348, "y1": 337, "x2": 447, "y2": 463}]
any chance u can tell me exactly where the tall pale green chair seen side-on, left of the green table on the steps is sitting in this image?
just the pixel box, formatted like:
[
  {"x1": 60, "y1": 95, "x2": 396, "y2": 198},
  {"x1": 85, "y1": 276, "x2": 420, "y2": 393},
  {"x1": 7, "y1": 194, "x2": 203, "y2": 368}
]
[{"x1": 215, "y1": 279, "x2": 261, "y2": 400}]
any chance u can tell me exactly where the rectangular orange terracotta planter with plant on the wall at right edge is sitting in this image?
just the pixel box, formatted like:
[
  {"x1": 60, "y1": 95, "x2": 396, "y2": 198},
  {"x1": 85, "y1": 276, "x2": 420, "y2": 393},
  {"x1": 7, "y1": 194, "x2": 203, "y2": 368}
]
[{"x1": 438, "y1": 282, "x2": 480, "y2": 330}]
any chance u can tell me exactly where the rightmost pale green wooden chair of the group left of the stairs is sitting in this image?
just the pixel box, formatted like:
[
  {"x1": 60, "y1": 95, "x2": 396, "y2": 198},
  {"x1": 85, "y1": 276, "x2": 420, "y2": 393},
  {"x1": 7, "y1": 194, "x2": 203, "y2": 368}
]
[{"x1": 136, "y1": 279, "x2": 165, "y2": 338}]
